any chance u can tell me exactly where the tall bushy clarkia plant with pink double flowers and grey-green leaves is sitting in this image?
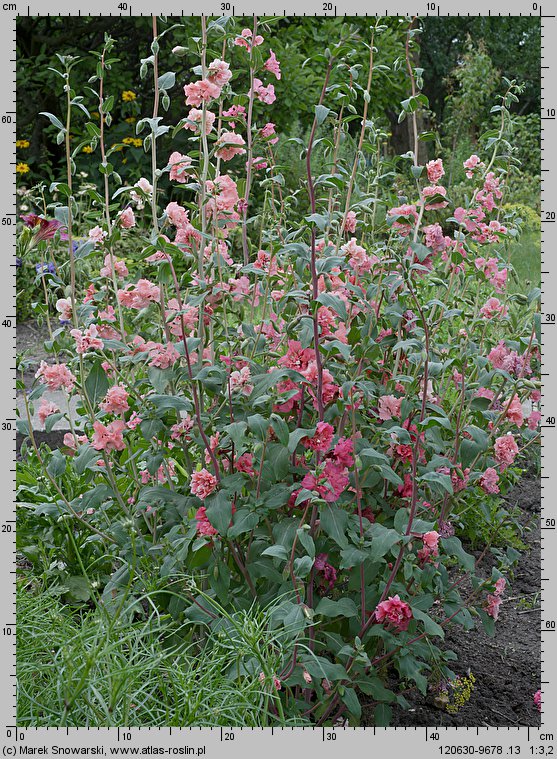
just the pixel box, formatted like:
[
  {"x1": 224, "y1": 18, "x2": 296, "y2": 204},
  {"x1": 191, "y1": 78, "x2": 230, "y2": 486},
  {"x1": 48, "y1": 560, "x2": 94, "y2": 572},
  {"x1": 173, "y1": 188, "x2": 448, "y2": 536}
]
[{"x1": 17, "y1": 18, "x2": 540, "y2": 724}]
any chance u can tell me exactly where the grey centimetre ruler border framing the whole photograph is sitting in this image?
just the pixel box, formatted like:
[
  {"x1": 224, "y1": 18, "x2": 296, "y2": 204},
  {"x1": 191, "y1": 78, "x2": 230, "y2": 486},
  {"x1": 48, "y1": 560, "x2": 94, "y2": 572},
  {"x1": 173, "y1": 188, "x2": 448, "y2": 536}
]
[{"x1": 4, "y1": 0, "x2": 557, "y2": 757}]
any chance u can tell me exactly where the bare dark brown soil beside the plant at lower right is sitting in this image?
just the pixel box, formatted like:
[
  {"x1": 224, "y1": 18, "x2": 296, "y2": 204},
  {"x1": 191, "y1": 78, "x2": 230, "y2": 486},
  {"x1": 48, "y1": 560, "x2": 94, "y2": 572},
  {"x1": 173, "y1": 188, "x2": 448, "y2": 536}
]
[{"x1": 372, "y1": 470, "x2": 541, "y2": 727}]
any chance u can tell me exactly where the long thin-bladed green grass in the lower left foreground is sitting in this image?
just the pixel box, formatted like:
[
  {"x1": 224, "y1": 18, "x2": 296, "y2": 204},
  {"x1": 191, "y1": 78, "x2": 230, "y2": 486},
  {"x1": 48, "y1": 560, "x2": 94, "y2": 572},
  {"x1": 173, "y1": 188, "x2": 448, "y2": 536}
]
[{"x1": 17, "y1": 588, "x2": 308, "y2": 727}]
